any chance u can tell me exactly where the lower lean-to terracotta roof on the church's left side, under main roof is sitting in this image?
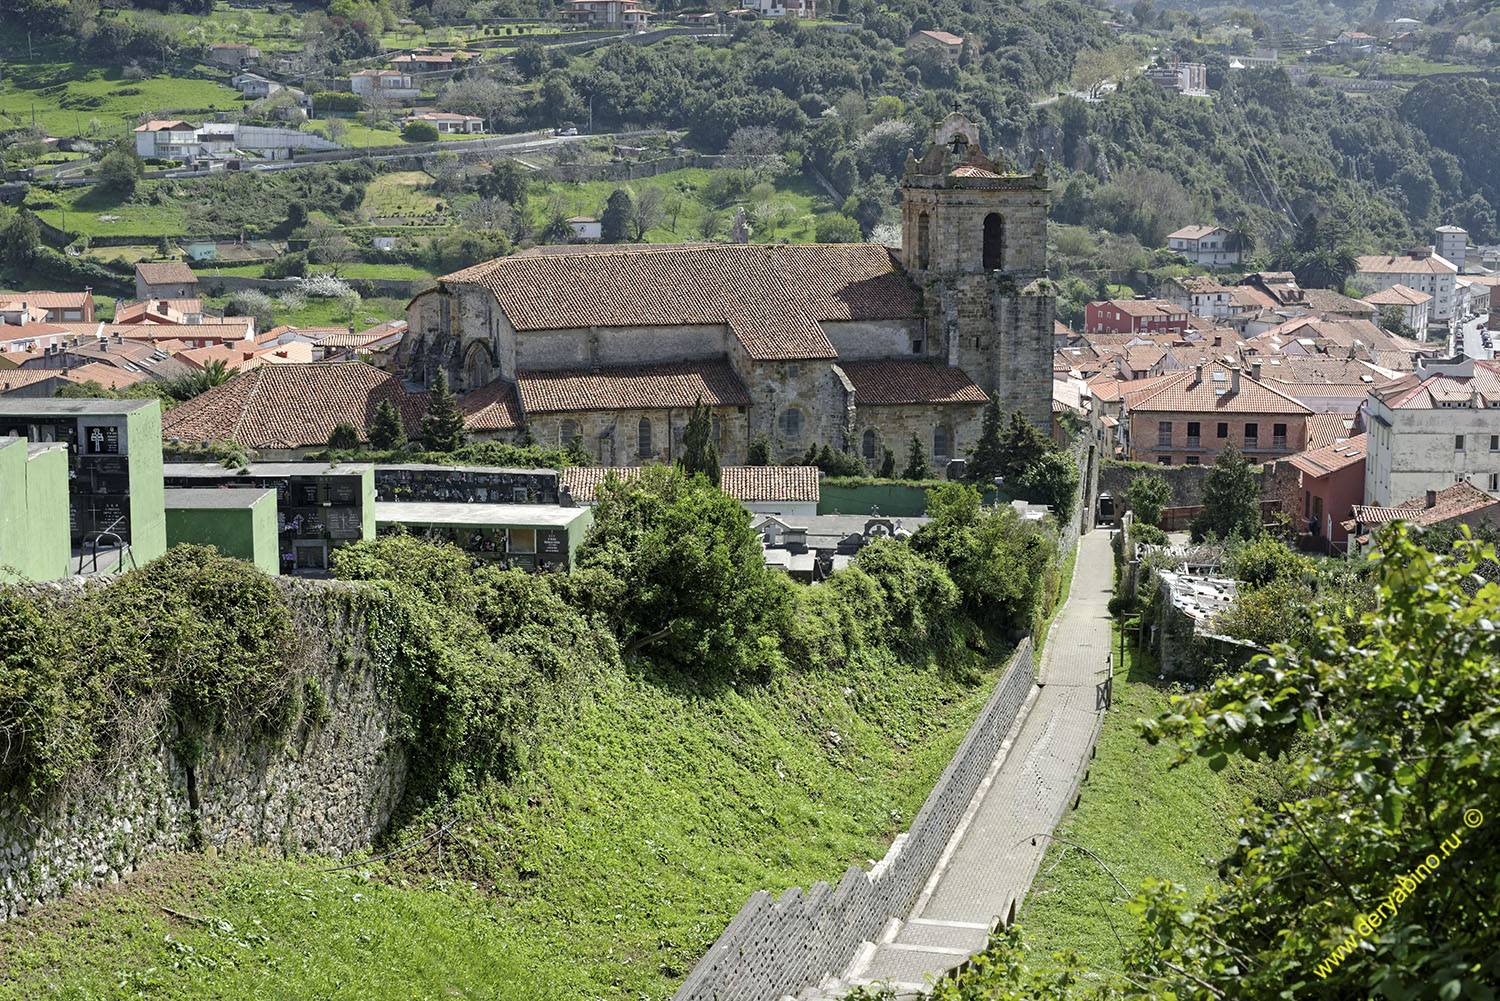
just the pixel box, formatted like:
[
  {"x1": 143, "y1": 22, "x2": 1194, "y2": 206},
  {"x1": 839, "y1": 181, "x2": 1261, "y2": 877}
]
[{"x1": 516, "y1": 362, "x2": 750, "y2": 414}]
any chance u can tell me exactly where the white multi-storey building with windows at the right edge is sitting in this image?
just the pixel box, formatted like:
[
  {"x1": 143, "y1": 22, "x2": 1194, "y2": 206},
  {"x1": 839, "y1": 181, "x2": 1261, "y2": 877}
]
[{"x1": 1365, "y1": 359, "x2": 1500, "y2": 507}]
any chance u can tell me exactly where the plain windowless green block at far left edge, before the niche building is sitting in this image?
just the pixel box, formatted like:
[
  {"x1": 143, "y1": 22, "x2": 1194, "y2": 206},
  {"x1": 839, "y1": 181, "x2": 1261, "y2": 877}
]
[{"x1": 0, "y1": 438, "x2": 72, "y2": 581}]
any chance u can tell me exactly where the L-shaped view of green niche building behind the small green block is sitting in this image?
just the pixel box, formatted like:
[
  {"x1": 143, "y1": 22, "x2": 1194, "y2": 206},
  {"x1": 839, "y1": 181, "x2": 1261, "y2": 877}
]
[{"x1": 165, "y1": 462, "x2": 375, "y2": 576}]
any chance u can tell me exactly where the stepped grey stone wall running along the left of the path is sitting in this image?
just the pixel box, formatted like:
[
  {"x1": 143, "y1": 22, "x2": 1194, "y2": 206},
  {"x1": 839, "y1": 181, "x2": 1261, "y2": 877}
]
[{"x1": 672, "y1": 639, "x2": 1035, "y2": 1001}]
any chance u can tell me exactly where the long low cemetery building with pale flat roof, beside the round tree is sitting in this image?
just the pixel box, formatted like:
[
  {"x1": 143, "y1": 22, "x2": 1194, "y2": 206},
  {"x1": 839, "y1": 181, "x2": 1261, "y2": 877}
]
[{"x1": 375, "y1": 501, "x2": 594, "y2": 572}]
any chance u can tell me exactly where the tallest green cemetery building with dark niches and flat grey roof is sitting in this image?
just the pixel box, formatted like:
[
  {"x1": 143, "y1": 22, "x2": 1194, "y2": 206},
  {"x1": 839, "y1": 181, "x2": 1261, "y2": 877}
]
[{"x1": 0, "y1": 396, "x2": 167, "y2": 572}]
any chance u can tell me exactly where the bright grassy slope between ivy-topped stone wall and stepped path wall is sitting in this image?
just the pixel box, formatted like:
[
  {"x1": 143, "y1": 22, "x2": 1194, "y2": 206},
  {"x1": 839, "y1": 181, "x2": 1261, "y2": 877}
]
[{"x1": 0, "y1": 654, "x2": 995, "y2": 1001}]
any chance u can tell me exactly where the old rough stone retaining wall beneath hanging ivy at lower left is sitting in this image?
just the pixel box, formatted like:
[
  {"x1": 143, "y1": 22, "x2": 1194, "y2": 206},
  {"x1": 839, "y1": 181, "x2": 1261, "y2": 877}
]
[{"x1": 0, "y1": 579, "x2": 408, "y2": 918}]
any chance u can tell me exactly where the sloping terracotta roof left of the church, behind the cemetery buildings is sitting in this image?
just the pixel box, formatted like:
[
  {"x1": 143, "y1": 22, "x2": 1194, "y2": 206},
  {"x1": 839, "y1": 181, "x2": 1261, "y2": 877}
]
[{"x1": 162, "y1": 362, "x2": 426, "y2": 449}]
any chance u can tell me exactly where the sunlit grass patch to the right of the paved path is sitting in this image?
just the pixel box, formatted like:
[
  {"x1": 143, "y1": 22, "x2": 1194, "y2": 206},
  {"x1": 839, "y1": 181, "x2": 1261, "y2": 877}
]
[{"x1": 1022, "y1": 618, "x2": 1277, "y2": 969}]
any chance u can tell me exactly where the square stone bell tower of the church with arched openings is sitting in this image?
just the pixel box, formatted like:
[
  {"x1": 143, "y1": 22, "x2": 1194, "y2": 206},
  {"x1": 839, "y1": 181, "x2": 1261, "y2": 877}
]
[{"x1": 902, "y1": 111, "x2": 1053, "y2": 429}]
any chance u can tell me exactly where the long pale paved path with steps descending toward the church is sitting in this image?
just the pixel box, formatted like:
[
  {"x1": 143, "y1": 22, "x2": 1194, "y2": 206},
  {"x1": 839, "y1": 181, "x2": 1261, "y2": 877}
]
[{"x1": 842, "y1": 531, "x2": 1115, "y2": 989}]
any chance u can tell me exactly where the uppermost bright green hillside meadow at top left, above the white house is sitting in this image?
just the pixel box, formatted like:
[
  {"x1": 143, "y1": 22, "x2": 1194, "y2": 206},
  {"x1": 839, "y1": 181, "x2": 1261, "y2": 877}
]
[{"x1": 0, "y1": 62, "x2": 243, "y2": 138}]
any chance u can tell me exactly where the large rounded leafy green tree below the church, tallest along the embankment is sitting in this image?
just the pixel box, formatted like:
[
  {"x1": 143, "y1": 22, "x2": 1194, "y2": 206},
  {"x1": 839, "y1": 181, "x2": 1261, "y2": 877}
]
[{"x1": 576, "y1": 465, "x2": 791, "y2": 681}]
